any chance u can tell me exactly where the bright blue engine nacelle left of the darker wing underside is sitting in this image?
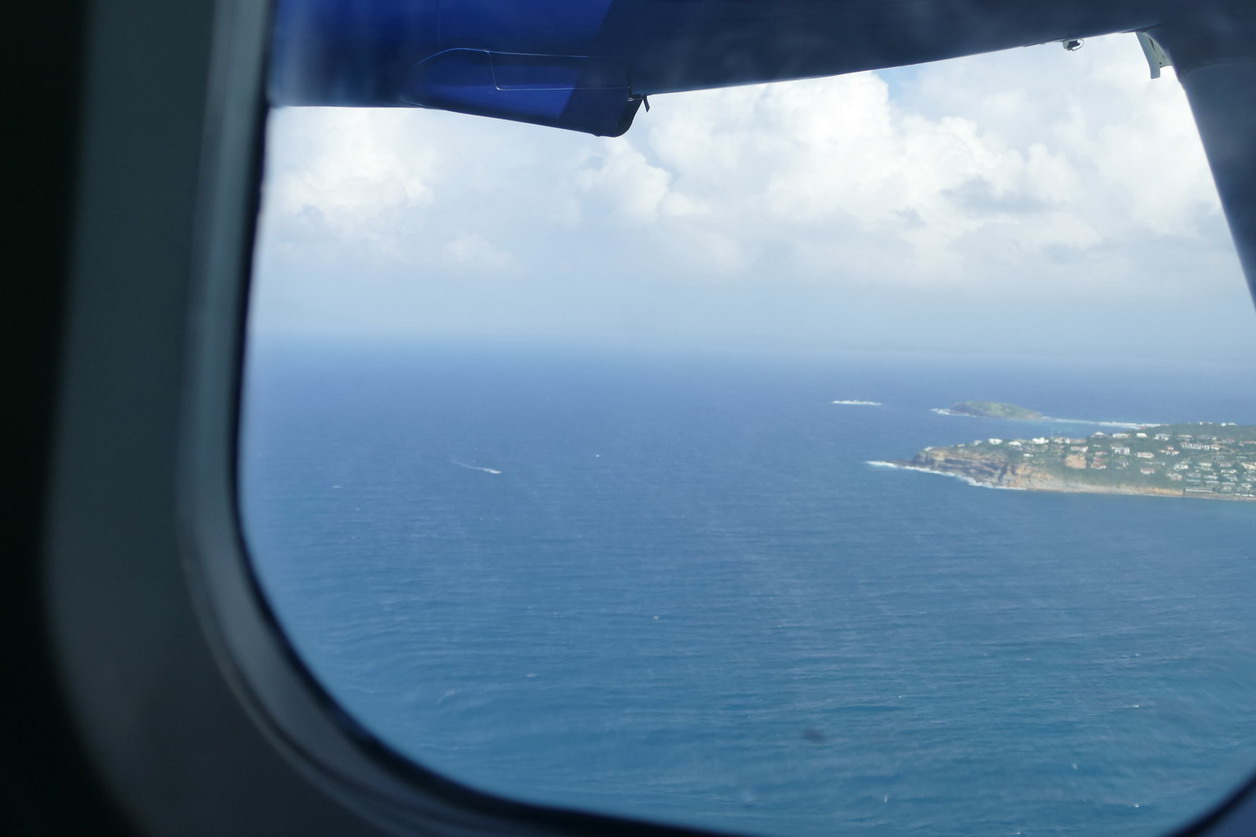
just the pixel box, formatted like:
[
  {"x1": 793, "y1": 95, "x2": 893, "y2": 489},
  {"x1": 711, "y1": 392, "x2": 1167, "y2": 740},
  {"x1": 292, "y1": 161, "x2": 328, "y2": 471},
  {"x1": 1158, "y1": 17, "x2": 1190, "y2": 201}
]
[{"x1": 270, "y1": 0, "x2": 642, "y2": 136}]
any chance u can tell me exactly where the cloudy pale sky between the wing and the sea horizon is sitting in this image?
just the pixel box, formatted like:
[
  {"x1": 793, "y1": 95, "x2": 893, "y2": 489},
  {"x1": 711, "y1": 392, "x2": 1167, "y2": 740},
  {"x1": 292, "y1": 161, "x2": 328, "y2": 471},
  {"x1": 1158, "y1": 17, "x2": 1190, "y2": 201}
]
[{"x1": 251, "y1": 35, "x2": 1256, "y2": 358}]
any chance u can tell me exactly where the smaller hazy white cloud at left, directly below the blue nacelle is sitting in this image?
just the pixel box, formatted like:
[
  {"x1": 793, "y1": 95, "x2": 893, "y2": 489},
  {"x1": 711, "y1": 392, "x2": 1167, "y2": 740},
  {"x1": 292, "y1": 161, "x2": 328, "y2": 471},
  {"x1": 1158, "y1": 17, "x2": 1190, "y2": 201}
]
[{"x1": 261, "y1": 108, "x2": 584, "y2": 267}]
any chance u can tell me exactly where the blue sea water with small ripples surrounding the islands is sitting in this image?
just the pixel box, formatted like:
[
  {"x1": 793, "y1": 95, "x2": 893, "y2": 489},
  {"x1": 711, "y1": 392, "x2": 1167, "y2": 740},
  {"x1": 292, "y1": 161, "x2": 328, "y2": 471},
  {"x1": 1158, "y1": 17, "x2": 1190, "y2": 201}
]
[{"x1": 241, "y1": 342, "x2": 1256, "y2": 836}]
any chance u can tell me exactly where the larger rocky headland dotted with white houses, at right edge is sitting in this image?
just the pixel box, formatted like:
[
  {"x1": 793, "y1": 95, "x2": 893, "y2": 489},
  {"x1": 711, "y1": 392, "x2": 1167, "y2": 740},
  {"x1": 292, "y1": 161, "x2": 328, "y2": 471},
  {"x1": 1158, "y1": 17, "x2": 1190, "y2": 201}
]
[{"x1": 878, "y1": 422, "x2": 1256, "y2": 500}]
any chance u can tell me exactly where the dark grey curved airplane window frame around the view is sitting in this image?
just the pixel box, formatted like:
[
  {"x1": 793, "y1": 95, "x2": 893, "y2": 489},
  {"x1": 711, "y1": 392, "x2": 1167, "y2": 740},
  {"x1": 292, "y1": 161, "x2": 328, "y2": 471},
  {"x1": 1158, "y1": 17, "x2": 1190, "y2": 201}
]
[{"x1": 44, "y1": 0, "x2": 1256, "y2": 837}]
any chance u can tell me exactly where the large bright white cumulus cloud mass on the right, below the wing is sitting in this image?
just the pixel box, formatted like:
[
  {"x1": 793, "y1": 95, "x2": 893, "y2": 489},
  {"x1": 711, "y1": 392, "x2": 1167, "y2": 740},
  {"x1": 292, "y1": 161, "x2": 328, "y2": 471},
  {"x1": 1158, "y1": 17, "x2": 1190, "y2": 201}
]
[{"x1": 590, "y1": 38, "x2": 1226, "y2": 288}]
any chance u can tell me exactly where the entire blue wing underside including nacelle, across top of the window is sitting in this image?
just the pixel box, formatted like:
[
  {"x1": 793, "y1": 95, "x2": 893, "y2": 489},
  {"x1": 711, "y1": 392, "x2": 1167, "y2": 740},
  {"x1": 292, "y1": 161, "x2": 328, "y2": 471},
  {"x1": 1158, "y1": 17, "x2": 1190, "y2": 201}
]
[{"x1": 270, "y1": 0, "x2": 1179, "y2": 136}]
